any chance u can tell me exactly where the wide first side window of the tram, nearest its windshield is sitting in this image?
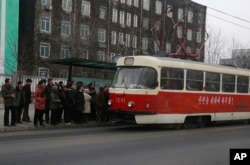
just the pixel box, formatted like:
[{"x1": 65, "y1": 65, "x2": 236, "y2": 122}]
[{"x1": 161, "y1": 68, "x2": 184, "y2": 90}]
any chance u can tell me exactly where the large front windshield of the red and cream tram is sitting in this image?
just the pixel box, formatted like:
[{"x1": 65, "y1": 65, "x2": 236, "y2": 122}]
[{"x1": 112, "y1": 67, "x2": 158, "y2": 89}]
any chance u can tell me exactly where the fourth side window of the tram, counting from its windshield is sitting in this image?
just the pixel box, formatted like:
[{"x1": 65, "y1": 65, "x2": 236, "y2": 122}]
[{"x1": 222, "y1": 74, "x2": 235, "y2": 92}]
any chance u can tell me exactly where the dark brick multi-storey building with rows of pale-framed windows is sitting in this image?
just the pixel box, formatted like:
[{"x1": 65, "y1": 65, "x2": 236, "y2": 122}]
[{"x1": 18, "y1": 0, "x2": 206, "y2": 78}]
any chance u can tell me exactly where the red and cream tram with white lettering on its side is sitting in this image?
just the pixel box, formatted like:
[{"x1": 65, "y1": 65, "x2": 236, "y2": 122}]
[{"x1": 109, "y1": 56, "x2": 250, "y2": 126}]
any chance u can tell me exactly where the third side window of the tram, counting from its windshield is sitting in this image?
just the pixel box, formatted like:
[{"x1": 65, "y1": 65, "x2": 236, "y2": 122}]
[{"x1": 206, "y1": 72, "x2": 220, "y2": 92}]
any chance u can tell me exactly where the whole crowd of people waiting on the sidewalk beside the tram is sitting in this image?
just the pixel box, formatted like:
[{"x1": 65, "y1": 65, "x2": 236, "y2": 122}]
[{"x1": 2, "y1": 78, "x2": 110, "y2": 127}]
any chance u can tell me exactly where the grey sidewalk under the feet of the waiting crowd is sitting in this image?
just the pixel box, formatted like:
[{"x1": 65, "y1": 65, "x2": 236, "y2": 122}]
[{"x1": 0, "y1": 104, "x2": 98, "y2": 133}]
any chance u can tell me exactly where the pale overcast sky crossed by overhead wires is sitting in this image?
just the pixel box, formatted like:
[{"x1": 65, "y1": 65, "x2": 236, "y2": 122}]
[{"x1": 192, "y1": 0, "x2": 250, "y2": 48}]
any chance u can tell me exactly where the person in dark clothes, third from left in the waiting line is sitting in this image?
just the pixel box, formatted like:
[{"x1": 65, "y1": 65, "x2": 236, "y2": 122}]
[{"x1": 22, "y1": 79, "x2": 32, "y2": 122}]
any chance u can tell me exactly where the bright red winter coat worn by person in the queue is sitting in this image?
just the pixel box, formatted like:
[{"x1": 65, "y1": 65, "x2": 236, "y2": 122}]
[{"x1": 34, "y1": 86, "x2": 46, "y2": 110}]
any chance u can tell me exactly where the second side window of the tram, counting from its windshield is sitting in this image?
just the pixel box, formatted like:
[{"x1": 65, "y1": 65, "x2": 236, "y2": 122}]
[{"x1": 186, "y1": 70, "x2": 203, "y2": 91}]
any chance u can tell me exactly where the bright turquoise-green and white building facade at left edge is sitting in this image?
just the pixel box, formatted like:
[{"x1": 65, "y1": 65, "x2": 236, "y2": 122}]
[{"x1": 0, "y1": 0, "x2": 19, "y2": 74}]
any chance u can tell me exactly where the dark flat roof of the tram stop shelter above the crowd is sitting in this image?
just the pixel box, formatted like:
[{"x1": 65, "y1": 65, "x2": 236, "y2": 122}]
[{"x1": 49, "y1": 57, "x2": 116, "y2": 70}]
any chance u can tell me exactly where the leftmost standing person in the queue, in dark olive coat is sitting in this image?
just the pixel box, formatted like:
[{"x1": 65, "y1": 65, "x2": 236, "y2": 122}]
[{"x1": 2, "y1": 78, "x2": 16, "y2": 126}]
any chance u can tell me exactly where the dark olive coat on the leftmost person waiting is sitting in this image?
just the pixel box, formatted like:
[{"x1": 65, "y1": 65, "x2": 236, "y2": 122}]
[{"x1": 2, "y1": 85, "x2": 16, "y2": 107}]
